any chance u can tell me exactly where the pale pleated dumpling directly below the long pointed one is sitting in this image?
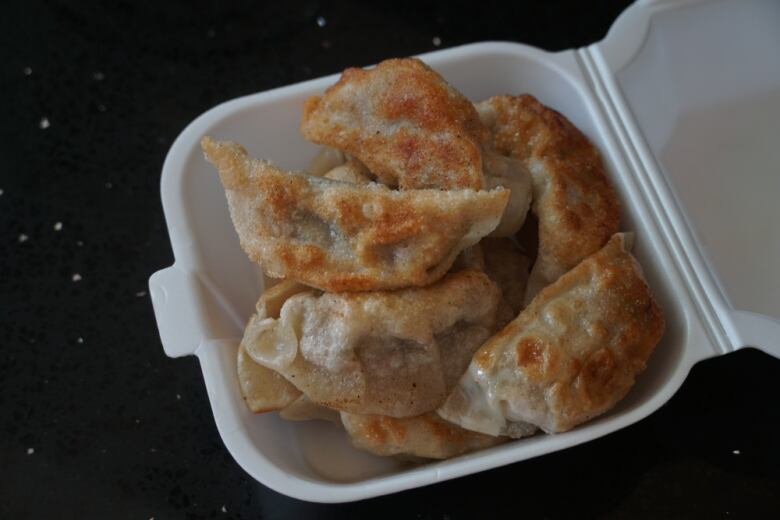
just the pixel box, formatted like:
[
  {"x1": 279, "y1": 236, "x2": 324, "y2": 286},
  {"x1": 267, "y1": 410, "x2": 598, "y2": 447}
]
[{"x1": 241, "y1": 270, "x2": 500, "y2": 417}]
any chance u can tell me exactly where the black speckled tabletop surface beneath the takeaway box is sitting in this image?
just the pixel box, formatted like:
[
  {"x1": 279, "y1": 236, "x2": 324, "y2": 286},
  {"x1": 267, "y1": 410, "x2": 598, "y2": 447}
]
[{"x1": 0, "y1": 1, "x2": 780, "y2": 520}]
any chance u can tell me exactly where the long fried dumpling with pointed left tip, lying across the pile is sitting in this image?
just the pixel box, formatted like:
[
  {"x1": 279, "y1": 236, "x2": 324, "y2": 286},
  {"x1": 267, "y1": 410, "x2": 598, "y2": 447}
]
[{"x1": 201, "y1": 137, "x2": 509, "y2": 291}]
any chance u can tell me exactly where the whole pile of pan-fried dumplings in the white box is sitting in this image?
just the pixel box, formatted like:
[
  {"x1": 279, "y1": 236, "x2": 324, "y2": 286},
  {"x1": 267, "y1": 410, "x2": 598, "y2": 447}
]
[{"x1": 201, "y1": 59, "x2": 664, "y2": 460}]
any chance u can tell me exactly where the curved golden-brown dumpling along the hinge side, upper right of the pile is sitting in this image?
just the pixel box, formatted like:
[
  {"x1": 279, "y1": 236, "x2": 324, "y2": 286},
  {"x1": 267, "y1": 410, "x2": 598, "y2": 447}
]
[{"x1": 477, "y1": 95, "x2": 620, "y2": 303}]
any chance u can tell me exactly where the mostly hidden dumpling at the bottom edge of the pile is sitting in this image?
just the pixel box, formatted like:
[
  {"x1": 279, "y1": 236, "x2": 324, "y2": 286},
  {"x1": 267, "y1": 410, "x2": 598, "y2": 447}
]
[{"x1": 341, "y1": 412, "x2": 507, "y2": 459}]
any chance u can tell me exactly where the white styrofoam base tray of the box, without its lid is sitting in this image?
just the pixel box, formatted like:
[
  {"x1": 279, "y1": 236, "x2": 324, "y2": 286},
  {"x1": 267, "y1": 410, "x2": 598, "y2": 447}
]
[{"x1": 150, "y1": 43, "x2": 717, "y2": 502}]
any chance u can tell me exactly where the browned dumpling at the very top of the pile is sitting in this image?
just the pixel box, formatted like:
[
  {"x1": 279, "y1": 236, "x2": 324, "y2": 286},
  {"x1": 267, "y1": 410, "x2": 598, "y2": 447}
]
[{"x1": 301, "y1": 58, "x2": 487, "y2": 190}]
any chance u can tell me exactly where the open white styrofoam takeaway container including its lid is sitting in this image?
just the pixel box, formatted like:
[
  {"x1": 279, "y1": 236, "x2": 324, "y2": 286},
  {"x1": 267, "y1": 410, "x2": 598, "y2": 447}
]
[{"x1": 149, "y1": 0, "x2": 780, "y2": 502}]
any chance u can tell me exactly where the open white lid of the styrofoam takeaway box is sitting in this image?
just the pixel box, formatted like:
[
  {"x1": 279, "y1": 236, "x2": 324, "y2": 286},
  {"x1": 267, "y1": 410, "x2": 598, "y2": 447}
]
[{"x1": 592, "y1": 0, "x2": 780, "y2": 353}]
